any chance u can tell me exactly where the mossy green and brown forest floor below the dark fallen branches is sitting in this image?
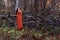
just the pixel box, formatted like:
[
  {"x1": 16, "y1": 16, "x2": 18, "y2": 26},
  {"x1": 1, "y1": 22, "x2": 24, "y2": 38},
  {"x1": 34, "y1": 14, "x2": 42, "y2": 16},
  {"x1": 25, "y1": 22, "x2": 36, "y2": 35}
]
[{"x1": 0, "y1": 27, "x2": 60, "y2": 40}]
